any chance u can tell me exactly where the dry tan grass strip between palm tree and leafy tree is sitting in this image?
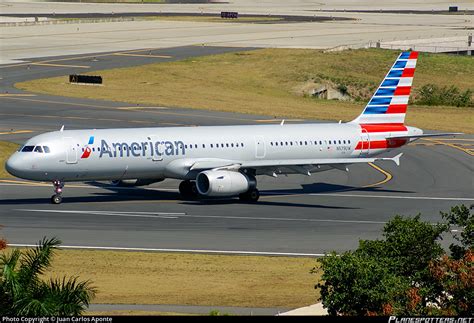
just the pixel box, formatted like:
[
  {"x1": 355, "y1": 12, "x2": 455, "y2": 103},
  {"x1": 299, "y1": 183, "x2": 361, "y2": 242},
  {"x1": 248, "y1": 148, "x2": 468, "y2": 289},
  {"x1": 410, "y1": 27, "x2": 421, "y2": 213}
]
[{"x1": 30, "y1": 250, "x2": 319, "y2": 308}]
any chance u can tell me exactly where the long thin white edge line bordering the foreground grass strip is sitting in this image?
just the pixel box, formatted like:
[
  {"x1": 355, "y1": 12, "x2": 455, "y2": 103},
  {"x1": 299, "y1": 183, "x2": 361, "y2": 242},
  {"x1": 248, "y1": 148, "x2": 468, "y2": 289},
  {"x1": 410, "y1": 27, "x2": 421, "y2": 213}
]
[{"x1": 8, "y1": 243, "x2": 324, "y2": 257}]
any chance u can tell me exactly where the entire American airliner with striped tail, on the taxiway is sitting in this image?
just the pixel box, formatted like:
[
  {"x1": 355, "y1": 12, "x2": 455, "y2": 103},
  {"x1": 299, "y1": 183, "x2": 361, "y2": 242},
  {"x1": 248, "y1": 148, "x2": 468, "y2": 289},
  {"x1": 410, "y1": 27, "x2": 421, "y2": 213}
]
[{"x1": 6, "y1": 52, "x2": 456, "y2": 204}]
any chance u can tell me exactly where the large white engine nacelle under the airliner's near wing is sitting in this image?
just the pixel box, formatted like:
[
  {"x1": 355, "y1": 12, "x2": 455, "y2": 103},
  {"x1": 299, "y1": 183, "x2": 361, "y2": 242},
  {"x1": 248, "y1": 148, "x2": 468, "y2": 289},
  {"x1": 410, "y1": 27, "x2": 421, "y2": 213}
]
[{"x1": 196, "y1": 170, "x2": 256, "y2": 196}]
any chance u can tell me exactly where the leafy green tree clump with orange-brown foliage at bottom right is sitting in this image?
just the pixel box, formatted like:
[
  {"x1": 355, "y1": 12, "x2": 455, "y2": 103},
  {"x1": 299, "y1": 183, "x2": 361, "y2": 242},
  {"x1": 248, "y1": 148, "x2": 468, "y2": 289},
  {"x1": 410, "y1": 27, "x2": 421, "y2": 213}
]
[{"x1": 313, "y1": 206, "x2": 474, "y2": 315}]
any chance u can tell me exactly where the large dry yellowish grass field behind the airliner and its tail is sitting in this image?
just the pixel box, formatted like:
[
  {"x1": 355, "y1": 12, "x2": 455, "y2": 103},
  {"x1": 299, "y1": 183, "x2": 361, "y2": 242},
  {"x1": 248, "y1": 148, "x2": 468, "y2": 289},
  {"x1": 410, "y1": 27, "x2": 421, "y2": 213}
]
[{"x1": 16, "y1": 49, "x2": 474, "y2": 133}]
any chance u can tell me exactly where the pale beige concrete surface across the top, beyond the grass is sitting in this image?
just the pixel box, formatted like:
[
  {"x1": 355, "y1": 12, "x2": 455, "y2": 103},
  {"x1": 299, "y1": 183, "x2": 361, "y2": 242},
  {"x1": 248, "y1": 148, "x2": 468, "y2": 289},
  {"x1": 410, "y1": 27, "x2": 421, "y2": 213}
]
[{"x1": 0, "y1": 0, "x2": 474, "y2": 64}]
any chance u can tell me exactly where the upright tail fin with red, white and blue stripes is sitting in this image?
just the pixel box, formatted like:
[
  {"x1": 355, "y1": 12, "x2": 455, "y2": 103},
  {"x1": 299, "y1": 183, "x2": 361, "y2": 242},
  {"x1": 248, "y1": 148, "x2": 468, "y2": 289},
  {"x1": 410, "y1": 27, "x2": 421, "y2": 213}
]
[{"x1": 351, "y1": 52, "x2": 418, "y2": 124}]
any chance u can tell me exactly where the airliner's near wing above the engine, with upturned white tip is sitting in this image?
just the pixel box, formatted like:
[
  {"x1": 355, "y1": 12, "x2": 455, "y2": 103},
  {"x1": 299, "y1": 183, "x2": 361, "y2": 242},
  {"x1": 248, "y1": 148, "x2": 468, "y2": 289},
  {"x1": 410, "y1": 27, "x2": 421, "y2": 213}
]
[{"x1": 190, "y1": 153, "x2": 403, "y2": 170}]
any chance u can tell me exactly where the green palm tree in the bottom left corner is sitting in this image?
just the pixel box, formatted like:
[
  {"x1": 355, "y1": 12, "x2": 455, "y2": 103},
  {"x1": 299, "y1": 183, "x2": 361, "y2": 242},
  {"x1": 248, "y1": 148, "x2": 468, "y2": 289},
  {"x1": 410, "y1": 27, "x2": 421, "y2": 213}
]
[{"x1": 0, "y1": 238, "x2": 95, "y2": 316}]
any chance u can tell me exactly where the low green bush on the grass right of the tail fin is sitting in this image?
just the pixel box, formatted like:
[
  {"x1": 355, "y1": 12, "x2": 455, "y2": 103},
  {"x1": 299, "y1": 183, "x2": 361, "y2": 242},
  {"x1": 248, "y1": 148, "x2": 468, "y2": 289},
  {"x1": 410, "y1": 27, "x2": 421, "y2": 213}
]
[{"x1": 415, "y1": 84, "x2": 474, "y2": 107}]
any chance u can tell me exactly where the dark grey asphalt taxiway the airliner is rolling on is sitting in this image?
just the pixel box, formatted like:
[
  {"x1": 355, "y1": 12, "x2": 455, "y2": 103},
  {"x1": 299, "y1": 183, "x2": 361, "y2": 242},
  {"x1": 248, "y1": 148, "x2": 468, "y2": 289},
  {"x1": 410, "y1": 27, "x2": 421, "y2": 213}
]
[{"x1": 0, "y1": 46, "x2": 474, "y2": 255}]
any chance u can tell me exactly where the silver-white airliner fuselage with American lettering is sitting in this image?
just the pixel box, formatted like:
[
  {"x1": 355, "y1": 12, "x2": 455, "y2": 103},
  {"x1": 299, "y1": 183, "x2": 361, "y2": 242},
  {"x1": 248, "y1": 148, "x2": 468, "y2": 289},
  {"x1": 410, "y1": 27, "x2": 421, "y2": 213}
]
[{"x1": 7, "y1": 123, "x2": 410, "y2": 181}]
